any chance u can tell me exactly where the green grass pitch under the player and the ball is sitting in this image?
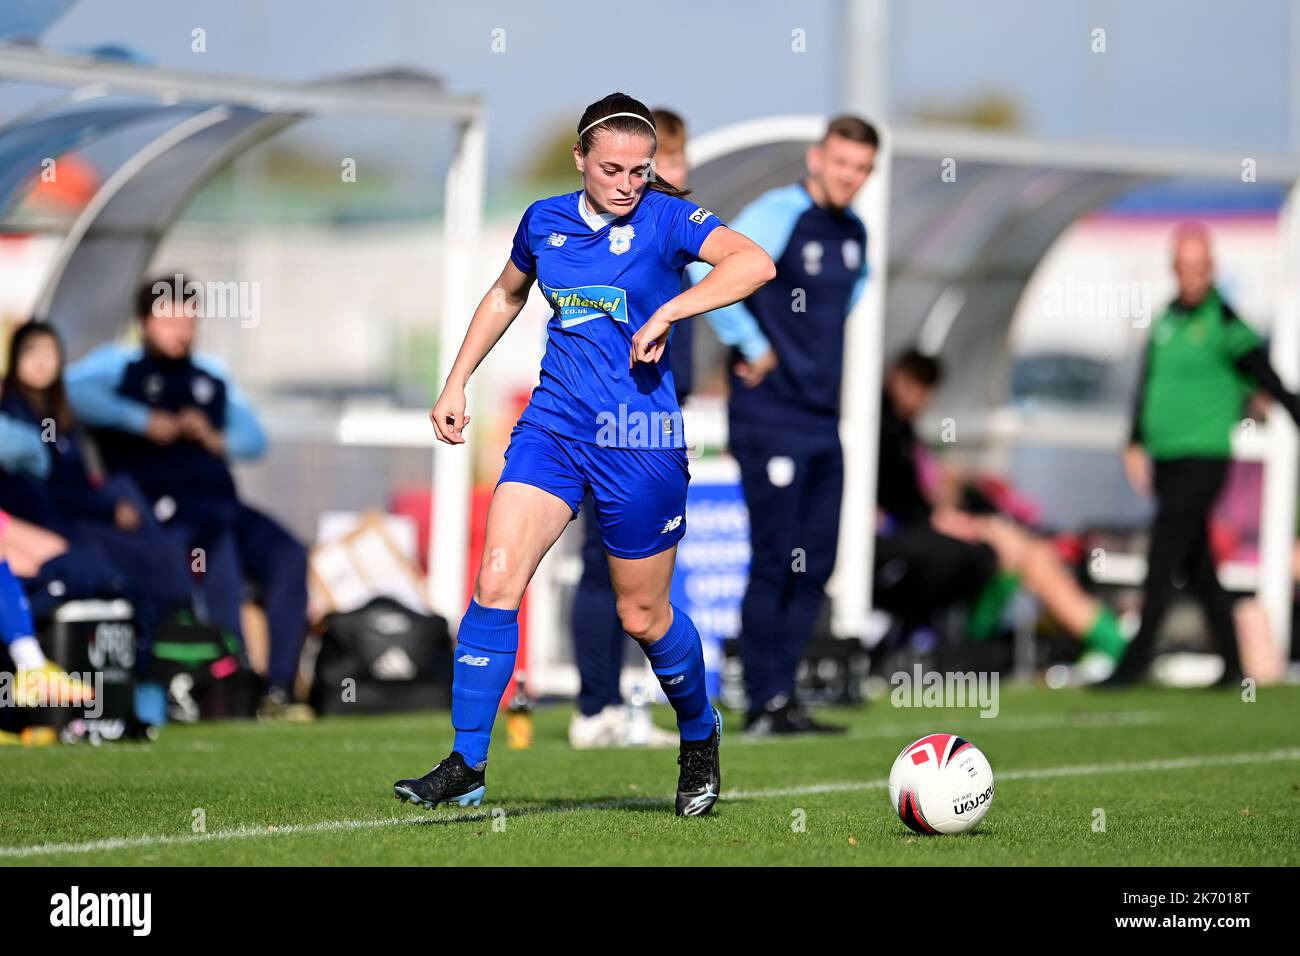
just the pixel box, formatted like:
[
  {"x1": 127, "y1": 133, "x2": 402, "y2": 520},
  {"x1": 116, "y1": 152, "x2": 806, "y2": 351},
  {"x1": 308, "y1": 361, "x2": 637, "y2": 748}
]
[{"x1": 0, "y1": 687, "x2": 1300, "y2": 866}]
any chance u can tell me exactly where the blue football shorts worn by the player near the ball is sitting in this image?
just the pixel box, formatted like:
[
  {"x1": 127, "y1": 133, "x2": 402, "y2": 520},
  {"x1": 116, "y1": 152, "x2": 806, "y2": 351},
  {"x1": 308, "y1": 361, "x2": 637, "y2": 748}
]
[{"x1": 497, "y1": 423, "x2": 690, "y2": 558}]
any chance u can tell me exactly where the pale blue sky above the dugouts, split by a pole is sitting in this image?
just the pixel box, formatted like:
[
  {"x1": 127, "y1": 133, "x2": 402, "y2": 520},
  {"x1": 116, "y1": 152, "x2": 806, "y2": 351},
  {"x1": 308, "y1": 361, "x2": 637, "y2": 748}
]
[{"x1": 0, "y1": 0, "x2": 1300, "y2": 184}]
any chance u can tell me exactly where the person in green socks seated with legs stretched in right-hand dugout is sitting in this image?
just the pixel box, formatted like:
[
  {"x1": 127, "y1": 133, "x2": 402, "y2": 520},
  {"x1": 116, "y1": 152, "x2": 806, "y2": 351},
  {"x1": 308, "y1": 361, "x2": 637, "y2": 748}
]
[{"x1": 874, "y1": 350, "x2": 1126, "y2": 662}]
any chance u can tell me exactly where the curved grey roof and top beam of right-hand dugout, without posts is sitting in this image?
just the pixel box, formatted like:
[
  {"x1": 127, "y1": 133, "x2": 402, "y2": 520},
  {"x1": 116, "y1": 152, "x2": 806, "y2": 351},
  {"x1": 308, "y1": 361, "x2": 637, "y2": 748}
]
[{"x1": 690, "y1": 117, "x2": 1300, "y2": 408}]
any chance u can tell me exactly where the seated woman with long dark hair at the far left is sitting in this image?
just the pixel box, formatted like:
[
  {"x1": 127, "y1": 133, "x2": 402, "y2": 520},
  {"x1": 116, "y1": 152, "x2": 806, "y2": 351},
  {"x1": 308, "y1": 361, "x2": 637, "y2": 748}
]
[{"x1": 0, "y1": 321, "x2": 192, "y2": 666}]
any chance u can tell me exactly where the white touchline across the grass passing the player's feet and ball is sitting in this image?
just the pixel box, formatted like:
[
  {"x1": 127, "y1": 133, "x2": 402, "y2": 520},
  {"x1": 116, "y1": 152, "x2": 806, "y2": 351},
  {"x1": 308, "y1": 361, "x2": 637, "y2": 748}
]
[{"x1": 0, "y1": 747, "x2": 1300, "y2": 860}]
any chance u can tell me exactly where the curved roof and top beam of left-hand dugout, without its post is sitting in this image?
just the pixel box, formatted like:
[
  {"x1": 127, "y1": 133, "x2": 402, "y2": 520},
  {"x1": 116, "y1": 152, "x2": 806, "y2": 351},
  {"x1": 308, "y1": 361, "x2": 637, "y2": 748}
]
[{"x1": 0, "y1": 47, "x2": 478, "y2": 356}]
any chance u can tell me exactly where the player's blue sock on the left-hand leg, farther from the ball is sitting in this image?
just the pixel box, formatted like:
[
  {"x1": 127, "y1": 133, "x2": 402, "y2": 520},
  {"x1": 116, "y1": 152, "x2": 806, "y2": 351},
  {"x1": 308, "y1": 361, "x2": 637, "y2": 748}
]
[{"x1": 451, "y1": 598, "x2": 519, "y2": 770}]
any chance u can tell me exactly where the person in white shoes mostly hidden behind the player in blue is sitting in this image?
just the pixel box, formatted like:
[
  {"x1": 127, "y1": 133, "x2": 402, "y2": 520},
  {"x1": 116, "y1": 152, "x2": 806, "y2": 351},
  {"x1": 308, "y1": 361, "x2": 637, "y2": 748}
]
[{"x1": 568, "y1": 102, "x2": 694, "y2": 749}]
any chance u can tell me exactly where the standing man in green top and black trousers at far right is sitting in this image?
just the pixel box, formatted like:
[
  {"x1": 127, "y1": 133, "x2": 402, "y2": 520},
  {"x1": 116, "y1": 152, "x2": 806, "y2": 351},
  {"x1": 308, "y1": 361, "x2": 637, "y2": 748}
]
[{"x1": 1105, "y1": 224, "x2": 1300, "y2": 687}]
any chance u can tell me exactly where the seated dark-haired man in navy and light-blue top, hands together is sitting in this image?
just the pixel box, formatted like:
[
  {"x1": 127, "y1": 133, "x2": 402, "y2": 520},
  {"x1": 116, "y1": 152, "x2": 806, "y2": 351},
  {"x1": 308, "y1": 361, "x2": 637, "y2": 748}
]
[{"x1": 68, "y1": 277, "x2": 307, "y2": 719}]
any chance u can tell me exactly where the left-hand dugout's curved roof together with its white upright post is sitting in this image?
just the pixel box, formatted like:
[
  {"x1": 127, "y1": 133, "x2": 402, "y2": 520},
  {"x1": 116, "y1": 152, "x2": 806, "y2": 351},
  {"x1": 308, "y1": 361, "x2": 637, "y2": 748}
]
[{"x1": 0, "y1": 47, "x2": 485, "y2": 620}]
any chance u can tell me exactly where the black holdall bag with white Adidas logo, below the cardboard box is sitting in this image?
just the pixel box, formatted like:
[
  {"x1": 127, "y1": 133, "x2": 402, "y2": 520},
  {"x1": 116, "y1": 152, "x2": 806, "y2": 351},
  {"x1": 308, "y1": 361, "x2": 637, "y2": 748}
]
[{"x1": 311, "y1": 597, "x2": 451, "y2": 714}]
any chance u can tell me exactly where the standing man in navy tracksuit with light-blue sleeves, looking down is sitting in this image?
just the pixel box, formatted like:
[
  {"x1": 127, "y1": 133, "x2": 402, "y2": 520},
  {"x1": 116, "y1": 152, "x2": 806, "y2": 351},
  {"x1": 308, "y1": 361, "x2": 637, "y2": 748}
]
[{"x1": 692, "y1": 116, "x2": 879, "y2": 735}]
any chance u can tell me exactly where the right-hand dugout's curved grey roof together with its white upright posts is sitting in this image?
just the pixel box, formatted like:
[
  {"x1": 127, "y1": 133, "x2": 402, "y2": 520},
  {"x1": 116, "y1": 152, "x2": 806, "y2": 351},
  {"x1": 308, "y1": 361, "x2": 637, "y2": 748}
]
[{"x1": 688, "y1": 116, "x2": 1300, "y2": 650}]
